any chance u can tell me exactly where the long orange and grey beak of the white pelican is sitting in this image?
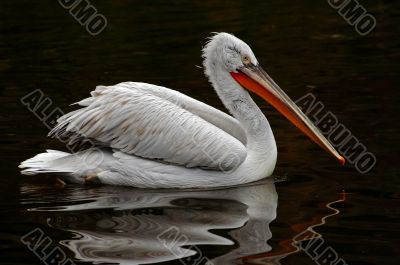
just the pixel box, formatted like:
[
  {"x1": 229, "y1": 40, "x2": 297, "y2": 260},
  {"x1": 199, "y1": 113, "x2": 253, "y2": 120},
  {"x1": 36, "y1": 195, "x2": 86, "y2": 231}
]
[{"x1": 230, "y1": 65, "x2": 346, "y2": 165}]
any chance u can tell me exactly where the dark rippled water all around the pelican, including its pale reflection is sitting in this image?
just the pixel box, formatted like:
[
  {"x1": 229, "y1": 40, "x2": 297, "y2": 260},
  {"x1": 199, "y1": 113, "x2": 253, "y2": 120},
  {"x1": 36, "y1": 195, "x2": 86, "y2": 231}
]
[{"x1": 0, "y1": 0, "x2": 400, "y2": 264}]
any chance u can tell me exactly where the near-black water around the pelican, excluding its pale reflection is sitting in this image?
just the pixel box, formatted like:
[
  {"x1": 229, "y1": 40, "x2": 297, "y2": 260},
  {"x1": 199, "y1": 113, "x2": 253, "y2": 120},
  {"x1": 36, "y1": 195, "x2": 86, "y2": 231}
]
[{"x1": 0, "y1": 0, "x2": 400, "y2": 264}]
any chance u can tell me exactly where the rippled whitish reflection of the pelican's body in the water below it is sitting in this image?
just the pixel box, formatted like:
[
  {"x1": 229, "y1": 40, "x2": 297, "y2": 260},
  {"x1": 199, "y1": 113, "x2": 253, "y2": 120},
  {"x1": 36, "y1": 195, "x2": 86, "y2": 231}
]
[{"x1": 39, "y1": 181, "x2": 277, "y2": 264}]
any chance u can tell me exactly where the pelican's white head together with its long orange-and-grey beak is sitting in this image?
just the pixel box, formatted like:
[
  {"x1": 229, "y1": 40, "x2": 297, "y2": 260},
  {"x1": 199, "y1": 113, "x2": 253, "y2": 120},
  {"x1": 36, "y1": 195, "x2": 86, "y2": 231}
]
[{"x1": 203, "y1": 33, "x2": 345, "y2": 164}]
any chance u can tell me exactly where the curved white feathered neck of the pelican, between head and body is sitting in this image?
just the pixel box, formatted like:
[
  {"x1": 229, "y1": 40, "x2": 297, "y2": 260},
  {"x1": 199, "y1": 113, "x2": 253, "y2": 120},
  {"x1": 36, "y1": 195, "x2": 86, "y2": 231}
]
[{"x1": 207, "y1": 68, "x2": 276, "y2": 154}]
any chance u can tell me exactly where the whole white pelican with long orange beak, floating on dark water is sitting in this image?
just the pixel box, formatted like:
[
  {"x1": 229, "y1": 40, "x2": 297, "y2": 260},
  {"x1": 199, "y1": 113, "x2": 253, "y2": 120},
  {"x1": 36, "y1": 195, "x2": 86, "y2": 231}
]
[{"x1": 20, "y1": 33, "x2": 345, "y2": 188}]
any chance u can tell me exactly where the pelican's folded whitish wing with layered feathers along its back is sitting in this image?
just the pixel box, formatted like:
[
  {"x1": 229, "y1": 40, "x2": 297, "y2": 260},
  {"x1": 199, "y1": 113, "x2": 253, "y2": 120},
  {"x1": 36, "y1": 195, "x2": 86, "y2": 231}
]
[{"x1": 50, "y1": 82, "x2": 246, "y2": 170}]
